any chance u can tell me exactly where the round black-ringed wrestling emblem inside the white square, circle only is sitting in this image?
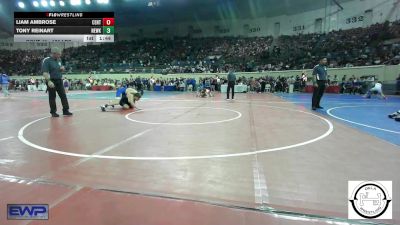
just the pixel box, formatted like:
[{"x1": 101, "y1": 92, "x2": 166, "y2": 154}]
[{"x1": 349, "y1": 181, "x2": 392, "y2": 219}]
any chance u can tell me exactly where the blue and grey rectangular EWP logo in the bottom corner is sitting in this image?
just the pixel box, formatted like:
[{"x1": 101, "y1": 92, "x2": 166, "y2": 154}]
[{"x1": 7, "y1": 204, "x2": 49, "y2": 220}]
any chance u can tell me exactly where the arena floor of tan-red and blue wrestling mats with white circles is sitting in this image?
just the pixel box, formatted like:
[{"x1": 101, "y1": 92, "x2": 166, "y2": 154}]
[{"x1": 0, "y1": 92, "x2": 400, "y2": 225}]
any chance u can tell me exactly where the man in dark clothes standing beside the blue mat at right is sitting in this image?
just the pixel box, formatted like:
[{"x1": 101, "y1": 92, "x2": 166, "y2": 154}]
[{"x1": 312, "y1": 58, "x2": 328, "y2": 110}]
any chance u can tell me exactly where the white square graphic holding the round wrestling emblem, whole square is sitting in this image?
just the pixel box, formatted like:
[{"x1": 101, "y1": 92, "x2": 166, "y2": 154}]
[{"x1": 348, "y1": 181, "x2": 392, "y2": 219}]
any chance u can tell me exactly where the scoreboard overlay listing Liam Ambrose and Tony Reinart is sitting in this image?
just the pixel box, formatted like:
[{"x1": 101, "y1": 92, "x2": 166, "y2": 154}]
[{"x1": 14, "y1": 12, "x2": 115, "y2": 42}]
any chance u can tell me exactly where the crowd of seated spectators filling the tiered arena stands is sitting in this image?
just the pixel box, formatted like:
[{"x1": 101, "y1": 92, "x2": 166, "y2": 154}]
[{"x1": 0, "y1": 21, "x2": 400, "y2": 75}]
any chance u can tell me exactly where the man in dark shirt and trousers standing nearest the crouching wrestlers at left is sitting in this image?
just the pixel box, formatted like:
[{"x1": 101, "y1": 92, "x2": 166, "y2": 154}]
[{"x1": 42, "y1": 47, "x2": 72, "y2": 117}]
